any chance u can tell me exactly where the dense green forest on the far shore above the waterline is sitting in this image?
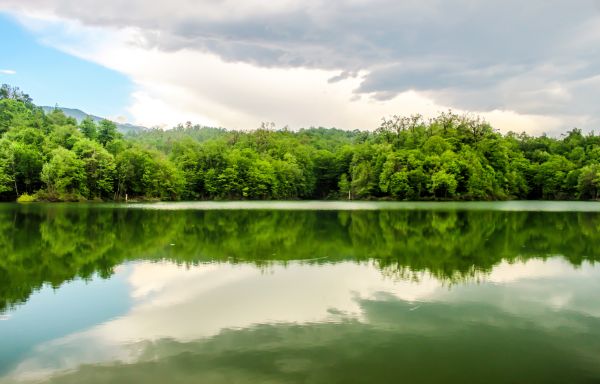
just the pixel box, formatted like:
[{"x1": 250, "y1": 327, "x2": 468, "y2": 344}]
[{"x1": 0, "y1": 85, "x2": 600, "y2": 201}]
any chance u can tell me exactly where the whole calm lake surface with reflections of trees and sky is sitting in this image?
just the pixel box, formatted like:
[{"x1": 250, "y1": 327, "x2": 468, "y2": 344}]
[{"x1": 0, "y1": 202, "x2": 600, "y2": 384}]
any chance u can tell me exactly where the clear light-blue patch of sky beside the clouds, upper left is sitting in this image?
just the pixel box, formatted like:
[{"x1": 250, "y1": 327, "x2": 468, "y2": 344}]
[{"x1": 0, "y1": 14, "x2": 133, "y2": 115}]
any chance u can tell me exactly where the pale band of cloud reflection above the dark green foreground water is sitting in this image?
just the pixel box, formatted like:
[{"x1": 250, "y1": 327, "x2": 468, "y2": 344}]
[{"x1": 0, "y1": 258, "x2": 600, "y2": 381}]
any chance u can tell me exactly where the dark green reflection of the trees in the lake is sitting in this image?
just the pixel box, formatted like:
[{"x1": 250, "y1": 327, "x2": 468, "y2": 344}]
[{"x1": 0, "y1": 205, "x2": 600, "y2": 309}]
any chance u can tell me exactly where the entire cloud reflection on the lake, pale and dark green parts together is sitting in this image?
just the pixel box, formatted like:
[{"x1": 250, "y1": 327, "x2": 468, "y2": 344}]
[{"x1": 5, "y1": 258, "x2": 600, "y2": 383}]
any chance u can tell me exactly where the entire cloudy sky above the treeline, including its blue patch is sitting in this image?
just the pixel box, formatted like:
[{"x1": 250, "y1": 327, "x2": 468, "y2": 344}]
[{"x1": 0, "y1": 0, "x2": 600, "y2": 134}]
